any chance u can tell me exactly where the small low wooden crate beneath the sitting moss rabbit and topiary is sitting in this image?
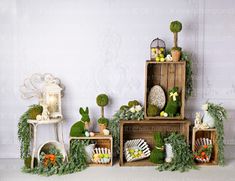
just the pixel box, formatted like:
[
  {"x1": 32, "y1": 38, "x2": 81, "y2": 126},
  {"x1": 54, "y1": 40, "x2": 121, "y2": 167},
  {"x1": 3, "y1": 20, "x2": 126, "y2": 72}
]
[{"x1": 70, "y1": 133, "x2": 113, "y2": 166}]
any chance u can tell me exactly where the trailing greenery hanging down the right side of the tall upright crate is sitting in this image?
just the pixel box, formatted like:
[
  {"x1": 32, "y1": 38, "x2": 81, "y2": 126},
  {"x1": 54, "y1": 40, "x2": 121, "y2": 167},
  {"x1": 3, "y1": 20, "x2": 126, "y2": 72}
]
[{"x1": 181, "y1": 52, "x2": 193, "y2": 99}]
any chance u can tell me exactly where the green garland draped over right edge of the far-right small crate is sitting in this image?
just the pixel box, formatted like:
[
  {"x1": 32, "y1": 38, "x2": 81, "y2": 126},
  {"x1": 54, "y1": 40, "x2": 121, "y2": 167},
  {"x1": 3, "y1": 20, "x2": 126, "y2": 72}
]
[{"x1": 208, "y1": 103, "x2": 227, "y2": 166}]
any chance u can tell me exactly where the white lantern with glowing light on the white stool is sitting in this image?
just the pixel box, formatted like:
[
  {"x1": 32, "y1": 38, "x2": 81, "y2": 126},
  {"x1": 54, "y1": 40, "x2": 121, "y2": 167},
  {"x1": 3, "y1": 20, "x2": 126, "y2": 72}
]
[{"x1": 43, "y1": 83, "x2": 62, "y2": 118}]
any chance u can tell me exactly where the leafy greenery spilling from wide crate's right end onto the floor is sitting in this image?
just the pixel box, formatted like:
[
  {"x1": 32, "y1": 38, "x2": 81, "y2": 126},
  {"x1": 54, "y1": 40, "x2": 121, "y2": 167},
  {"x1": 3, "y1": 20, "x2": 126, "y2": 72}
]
[{"x1": 157, "y1": 133, "x2": 197, "y2": 172}]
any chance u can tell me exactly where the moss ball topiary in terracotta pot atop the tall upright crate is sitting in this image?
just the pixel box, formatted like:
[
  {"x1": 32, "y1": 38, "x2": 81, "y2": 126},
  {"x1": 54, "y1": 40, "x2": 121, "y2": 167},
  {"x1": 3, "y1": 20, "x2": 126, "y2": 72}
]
[{"x1": 170, "y1": 21, "x2": 182, "y2": 62}]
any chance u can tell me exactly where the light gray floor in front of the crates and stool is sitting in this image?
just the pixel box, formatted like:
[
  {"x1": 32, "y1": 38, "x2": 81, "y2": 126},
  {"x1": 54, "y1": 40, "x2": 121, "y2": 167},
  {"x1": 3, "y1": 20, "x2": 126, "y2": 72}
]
[{"x1": 0, "y1": 146, "x2": 235, "y2": 181}]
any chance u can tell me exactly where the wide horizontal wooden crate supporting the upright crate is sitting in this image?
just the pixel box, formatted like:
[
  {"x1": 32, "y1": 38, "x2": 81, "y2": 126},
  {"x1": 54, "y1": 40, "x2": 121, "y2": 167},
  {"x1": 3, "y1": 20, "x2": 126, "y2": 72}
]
[{"x1": 119, "y1": 120, "x2": 190, "y2": 166}]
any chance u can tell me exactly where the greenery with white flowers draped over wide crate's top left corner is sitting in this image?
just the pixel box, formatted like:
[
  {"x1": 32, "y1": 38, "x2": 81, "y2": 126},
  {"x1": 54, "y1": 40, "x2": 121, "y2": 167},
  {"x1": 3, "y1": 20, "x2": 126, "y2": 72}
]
[{"x1": 109, "y1": 105, "x2": 144, "y2": 157}]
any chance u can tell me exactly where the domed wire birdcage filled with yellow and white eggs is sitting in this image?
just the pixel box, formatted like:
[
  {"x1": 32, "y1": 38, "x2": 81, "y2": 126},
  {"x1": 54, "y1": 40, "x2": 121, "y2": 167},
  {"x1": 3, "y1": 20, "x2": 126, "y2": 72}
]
[{"x1": 150, "y1": 38, "x2": 166, "y2": 62}]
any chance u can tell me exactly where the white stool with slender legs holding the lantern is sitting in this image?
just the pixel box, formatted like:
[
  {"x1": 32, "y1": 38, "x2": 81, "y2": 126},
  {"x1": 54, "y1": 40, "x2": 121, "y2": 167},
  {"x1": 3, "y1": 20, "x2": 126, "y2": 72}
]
[{"x1": 27, "y1": 118, "x2": 65, "y2": 168}]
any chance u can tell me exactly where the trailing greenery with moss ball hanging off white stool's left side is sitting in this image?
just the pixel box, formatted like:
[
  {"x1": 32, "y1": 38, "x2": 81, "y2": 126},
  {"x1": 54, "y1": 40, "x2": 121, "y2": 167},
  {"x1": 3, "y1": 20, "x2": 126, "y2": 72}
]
[{"x1": 18, "y1": 105, "x2": 42, "y2": 159}]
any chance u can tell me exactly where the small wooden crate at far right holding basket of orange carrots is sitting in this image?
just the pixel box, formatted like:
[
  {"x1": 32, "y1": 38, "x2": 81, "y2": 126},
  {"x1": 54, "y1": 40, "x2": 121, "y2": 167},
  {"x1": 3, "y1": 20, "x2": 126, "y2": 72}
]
[{"x1": 192, "y1": 128, "x2": 218, "y2": 165}]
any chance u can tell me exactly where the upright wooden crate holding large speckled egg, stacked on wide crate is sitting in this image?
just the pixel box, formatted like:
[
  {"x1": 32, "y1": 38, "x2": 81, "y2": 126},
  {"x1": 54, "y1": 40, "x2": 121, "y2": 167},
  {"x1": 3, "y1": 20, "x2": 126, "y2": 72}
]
[{"x1": 144, "y1": 61, "x2": 186, "y2": 119}]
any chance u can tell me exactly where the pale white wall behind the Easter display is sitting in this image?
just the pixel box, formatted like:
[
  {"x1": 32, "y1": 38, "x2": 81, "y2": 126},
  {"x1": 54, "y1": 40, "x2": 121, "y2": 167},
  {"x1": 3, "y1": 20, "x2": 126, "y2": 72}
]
[{"x1": 0, "y1": 0, "x2": 235, "y2": 157}]
